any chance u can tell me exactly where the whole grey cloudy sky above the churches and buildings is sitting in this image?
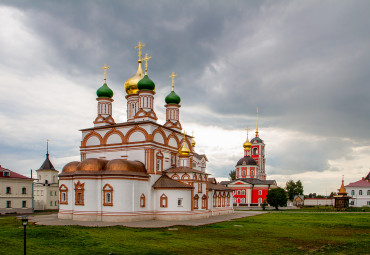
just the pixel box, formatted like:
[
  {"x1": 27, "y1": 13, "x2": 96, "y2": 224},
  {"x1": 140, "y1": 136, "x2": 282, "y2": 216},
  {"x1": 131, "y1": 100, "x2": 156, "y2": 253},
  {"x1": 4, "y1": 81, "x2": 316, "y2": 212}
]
[{"x1": 0, "y1": 0, "x2": 370, "y2": 193}]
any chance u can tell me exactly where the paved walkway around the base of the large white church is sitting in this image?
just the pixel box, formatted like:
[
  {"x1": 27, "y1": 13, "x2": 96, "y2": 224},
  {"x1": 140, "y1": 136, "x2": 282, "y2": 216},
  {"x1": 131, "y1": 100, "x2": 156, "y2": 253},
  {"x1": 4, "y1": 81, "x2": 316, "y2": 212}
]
[{"x1": 29, "y1": 211, "x2": 266, "y2": 228}]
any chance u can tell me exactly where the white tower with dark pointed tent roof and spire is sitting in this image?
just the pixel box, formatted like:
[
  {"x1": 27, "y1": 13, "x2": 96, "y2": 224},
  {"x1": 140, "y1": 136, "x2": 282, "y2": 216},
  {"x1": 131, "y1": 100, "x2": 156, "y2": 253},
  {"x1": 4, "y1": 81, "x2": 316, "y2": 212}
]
[{"x1": 33, "y1": 150, "x2": 59, "y2": 210}]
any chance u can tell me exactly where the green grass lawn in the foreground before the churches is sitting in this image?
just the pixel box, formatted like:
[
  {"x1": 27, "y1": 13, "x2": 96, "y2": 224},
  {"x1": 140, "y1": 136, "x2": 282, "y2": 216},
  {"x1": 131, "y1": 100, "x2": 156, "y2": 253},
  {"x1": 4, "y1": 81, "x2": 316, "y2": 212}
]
[{"x1": 0, "y1": 212, "x2": 370, "y2": 255}]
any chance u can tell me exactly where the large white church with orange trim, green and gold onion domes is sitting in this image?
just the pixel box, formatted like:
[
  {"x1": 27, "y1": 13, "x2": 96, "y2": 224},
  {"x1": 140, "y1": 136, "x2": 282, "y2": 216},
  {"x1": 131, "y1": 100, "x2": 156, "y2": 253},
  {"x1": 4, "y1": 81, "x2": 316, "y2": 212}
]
[{"x1": 58, "y1": 42, "x2": 233, "y2": 222}]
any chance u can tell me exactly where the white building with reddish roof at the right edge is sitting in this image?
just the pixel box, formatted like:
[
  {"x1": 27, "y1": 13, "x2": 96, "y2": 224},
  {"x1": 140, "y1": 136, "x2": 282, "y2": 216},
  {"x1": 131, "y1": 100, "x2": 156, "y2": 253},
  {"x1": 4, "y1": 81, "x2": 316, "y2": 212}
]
[{"x1": 345, "y1": 172, "x2": 370, "y2": 207}]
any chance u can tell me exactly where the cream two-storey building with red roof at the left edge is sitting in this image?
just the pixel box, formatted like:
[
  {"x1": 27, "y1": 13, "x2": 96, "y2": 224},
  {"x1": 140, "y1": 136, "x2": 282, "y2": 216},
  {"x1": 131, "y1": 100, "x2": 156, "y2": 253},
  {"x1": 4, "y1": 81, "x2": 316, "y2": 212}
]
[{"x1": 0, "y1": 166, "x2": 33, "y2": 214}]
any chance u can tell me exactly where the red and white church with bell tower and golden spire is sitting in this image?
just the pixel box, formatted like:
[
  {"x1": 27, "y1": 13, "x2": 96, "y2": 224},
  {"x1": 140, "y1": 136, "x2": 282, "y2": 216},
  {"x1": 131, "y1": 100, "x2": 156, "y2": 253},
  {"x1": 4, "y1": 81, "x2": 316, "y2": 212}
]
[{"x1": 221, "y1": 116, "x2": 277, "y2": 206}]
